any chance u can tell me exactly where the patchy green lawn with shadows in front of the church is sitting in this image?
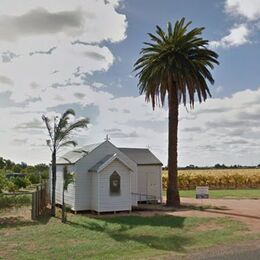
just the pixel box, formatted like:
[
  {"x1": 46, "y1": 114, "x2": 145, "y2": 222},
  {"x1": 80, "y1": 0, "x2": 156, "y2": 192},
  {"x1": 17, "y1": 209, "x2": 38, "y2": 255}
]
[{"x1": 0, "y1": 212, "x2": 256, "y2": 259}]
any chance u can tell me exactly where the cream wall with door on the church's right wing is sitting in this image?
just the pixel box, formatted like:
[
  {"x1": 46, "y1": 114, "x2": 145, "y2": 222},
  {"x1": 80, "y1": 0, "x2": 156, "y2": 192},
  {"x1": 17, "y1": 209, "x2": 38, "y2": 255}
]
[{"x1": 137, "y1": 165, "x2": 162, "y2": 201}]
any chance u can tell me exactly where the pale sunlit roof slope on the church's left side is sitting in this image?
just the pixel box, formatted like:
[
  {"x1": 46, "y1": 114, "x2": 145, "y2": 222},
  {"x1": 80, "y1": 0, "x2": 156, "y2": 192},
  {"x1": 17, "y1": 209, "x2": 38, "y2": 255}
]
[{"x1": 57, "y1": 143, "x2": 102, "y2": 164}]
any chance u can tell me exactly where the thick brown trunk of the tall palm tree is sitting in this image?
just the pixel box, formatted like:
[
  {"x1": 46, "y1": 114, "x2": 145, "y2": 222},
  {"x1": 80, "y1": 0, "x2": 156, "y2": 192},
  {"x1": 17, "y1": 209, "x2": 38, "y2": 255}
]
[{"x1": 166, "y1": 75, "x2": 180, "y2": 206}]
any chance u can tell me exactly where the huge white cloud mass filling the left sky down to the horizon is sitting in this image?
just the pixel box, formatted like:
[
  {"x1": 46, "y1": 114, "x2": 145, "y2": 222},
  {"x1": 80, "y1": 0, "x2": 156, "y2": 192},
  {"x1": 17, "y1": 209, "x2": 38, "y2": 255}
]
[{"x1": 0, "y1": 0, "x2": 127, "y2": 165}]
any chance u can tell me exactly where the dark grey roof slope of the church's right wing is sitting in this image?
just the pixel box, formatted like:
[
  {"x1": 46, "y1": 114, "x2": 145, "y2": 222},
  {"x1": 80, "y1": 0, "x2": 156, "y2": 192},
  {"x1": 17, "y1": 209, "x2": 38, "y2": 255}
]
[{"x1": 118, "y1": 148, "x2": 162, "y2": 165}]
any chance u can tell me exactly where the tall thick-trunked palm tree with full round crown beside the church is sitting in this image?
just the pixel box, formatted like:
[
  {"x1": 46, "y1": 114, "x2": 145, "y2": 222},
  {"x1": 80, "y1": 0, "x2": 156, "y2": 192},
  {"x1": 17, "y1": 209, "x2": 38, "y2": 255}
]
[{"x1": 134, "y1": 18, "x2": 219, "y2": 206}]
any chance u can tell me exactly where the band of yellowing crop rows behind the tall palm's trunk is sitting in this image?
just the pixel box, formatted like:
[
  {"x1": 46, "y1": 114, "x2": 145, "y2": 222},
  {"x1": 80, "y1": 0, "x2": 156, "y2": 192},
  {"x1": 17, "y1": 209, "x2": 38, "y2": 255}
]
[{"x1": 162, "y1": 169, "x2": 260, "y2": 190}]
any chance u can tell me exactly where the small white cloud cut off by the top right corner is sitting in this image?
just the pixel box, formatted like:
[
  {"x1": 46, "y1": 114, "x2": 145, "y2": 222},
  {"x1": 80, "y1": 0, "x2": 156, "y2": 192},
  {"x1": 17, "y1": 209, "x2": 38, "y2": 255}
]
[{"x1": 225, "y1": 0, "x2": 260, "y2": 21}]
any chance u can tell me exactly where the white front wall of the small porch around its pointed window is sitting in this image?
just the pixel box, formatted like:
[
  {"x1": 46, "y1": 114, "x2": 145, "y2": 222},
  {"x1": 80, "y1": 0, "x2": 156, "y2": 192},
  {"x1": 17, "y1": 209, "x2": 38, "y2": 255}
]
[{"x1": 96, "y1": 160, "x2": 132, "y2": 212}]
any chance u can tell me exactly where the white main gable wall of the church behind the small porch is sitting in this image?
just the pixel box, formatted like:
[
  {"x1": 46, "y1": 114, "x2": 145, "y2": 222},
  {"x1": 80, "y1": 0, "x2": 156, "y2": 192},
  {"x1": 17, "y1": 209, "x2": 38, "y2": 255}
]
[{"x1": 74, "y1": 141, "x2": 137, "y2": 211}]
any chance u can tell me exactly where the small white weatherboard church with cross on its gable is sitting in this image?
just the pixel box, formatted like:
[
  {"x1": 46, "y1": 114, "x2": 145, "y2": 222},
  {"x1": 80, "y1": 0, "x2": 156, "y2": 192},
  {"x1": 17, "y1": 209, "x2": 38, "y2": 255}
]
[{"x1": 49, "y1": 140, "x2": 162, "y2": 213}]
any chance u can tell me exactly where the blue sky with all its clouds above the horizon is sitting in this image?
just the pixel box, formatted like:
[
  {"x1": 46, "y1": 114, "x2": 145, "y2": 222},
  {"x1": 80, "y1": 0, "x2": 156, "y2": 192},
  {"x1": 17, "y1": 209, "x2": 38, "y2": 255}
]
[{"x1": 0, "y1": 0, "x2": 260, "y2": 166}]
